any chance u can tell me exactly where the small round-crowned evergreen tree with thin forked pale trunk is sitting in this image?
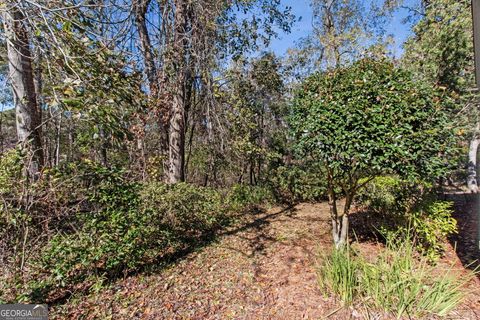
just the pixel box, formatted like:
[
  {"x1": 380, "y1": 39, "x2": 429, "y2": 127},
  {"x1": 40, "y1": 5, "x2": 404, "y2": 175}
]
[{"x1": 290, "y1": 59, "x2": 455, "y2": 248}]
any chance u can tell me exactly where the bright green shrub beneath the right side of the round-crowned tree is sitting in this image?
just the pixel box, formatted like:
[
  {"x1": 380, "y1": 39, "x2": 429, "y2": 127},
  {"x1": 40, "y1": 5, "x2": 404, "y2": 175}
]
[{"x1": 356, "y1": 176, "x2": 457, "y2": 261}]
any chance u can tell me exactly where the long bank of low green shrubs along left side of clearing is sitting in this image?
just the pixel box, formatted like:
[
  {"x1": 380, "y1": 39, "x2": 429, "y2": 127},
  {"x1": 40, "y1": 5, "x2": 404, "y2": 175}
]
[{"x1": 0, "y1": 156, "x2": 273, "y2": 301}]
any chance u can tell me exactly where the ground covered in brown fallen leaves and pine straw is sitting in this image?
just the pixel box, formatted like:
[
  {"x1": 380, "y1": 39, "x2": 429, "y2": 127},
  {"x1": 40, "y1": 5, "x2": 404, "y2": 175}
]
[{"x1": 50, "y1": 195, "x2": 480, "y2": 320}]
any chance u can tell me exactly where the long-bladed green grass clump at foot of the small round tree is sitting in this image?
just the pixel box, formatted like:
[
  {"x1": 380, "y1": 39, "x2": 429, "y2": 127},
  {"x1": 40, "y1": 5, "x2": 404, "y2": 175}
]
[{"x1": 319, "y1": 232, "x2": 473, "y2": 318}]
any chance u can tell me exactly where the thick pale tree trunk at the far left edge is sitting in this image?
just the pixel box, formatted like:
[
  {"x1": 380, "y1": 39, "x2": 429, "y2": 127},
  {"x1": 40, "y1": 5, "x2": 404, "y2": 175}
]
[{"x1": 2, "y1": 8, "x2": 44, "y2": 176}]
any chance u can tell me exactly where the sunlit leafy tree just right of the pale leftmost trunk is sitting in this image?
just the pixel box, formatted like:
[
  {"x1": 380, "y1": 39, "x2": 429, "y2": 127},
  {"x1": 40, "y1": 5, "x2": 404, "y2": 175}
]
[{"x1": 43, "y1": 31, "x2": 146, "y2": 166}]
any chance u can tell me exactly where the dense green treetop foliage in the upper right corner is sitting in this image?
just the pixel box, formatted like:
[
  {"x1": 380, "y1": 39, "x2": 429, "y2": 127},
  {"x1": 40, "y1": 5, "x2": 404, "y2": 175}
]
[{"x1": 402, "y1": 0, "x2": 474, "y2": 93}]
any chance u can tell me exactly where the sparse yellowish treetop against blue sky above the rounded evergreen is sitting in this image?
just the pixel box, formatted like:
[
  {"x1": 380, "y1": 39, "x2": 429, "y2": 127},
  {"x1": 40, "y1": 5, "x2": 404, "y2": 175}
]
[{"x1": 288, "y1": 0, "x2": 391, "y2": 79}]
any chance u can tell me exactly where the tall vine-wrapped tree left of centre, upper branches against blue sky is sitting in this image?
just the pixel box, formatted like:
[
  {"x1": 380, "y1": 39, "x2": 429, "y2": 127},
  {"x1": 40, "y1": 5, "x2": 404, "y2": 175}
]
[{"x1": 128, "y1": 0, "x2": 293, "y2": 183}]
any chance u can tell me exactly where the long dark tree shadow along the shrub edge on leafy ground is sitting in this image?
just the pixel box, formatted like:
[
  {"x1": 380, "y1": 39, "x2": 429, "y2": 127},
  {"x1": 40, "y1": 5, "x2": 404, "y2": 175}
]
[{"x1": 41, "y1": 204, "x2": 296, "y2": 306}]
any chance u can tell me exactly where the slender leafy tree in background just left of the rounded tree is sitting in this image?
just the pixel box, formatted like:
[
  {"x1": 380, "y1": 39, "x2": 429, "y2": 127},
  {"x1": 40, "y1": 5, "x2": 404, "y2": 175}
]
[{"x1": 225, "y1": 53, "x2": 284, "y2": 184}]
